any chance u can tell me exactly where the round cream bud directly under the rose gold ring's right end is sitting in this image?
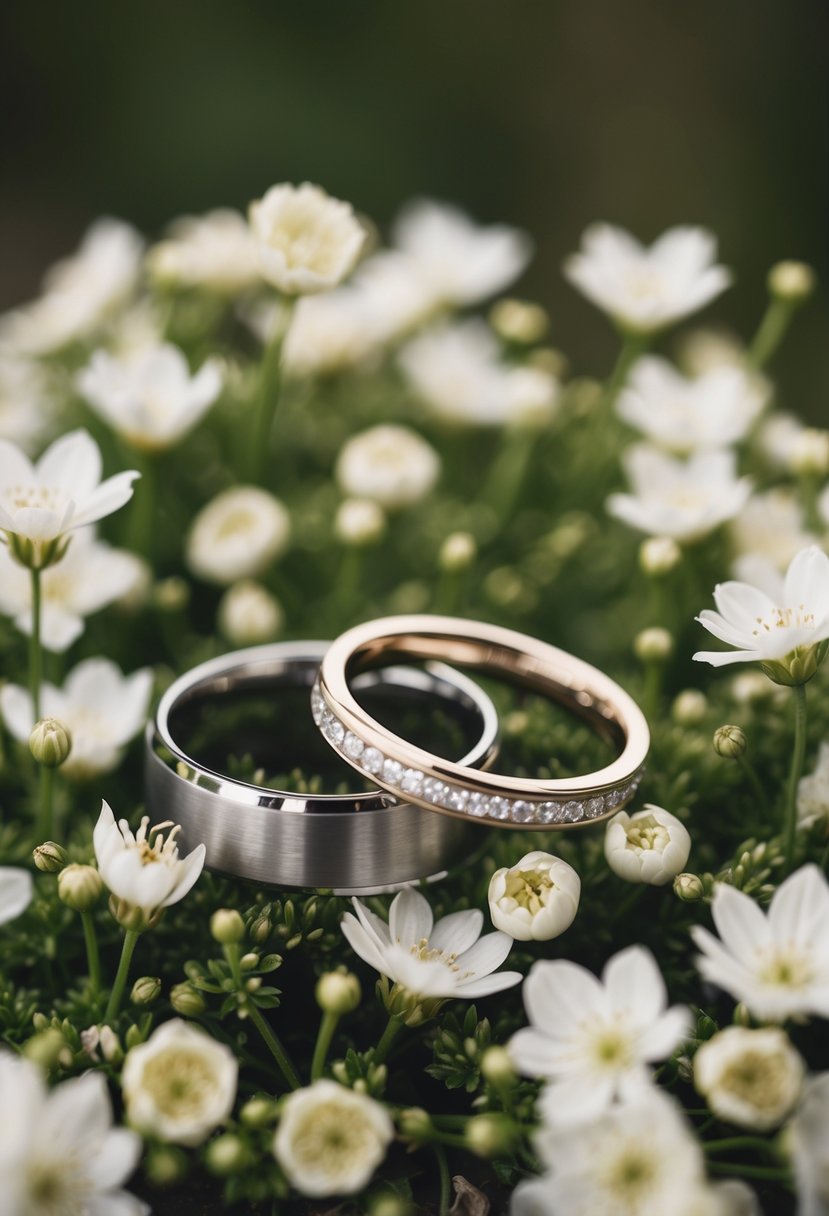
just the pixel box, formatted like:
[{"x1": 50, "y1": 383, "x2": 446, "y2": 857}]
[{"x1": 604, "y1": 803, "x2": 690, "y2": 886}]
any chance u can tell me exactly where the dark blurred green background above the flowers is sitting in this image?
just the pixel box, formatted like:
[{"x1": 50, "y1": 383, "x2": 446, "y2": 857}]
[{"x1": 0, "y1": 0, "x2": 829, "y2": 408}]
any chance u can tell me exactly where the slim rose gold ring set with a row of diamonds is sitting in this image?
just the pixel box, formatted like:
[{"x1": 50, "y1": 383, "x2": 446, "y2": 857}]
[{"x1": 311, "y1": 617, "x2": 650, "y2": 831}]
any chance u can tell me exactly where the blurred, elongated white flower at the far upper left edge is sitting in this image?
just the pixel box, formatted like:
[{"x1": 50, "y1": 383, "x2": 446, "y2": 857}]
[{"x1": 0, "y1": 219, "x2": 143, "y2": 355}]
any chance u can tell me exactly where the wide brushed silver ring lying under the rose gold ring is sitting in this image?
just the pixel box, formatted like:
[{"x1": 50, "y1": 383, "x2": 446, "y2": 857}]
[{"x1": 145, "y1": 642, "x2": 498, "y2": 894}]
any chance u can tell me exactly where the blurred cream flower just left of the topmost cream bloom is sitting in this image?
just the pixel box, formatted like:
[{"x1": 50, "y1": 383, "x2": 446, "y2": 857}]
[{"x1": 146, "y1": 207, "x2": 260, "y2": 297}]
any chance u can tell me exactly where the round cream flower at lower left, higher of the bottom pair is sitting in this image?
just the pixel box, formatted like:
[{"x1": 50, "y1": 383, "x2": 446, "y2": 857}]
[{"x1": 120, "y1": 1018, "x2": 238, "y2": 1145}]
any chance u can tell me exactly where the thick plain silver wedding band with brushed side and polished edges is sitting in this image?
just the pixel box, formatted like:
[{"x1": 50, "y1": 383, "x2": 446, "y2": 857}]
[{"x1": 145, "y1": 642, "x2": 497, "y2": 894}]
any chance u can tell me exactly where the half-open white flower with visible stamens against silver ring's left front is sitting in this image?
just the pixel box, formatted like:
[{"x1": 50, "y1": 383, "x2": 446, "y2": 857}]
[{"x1": 92, "y1": 803, "x2": 204, "y2": 922}]
